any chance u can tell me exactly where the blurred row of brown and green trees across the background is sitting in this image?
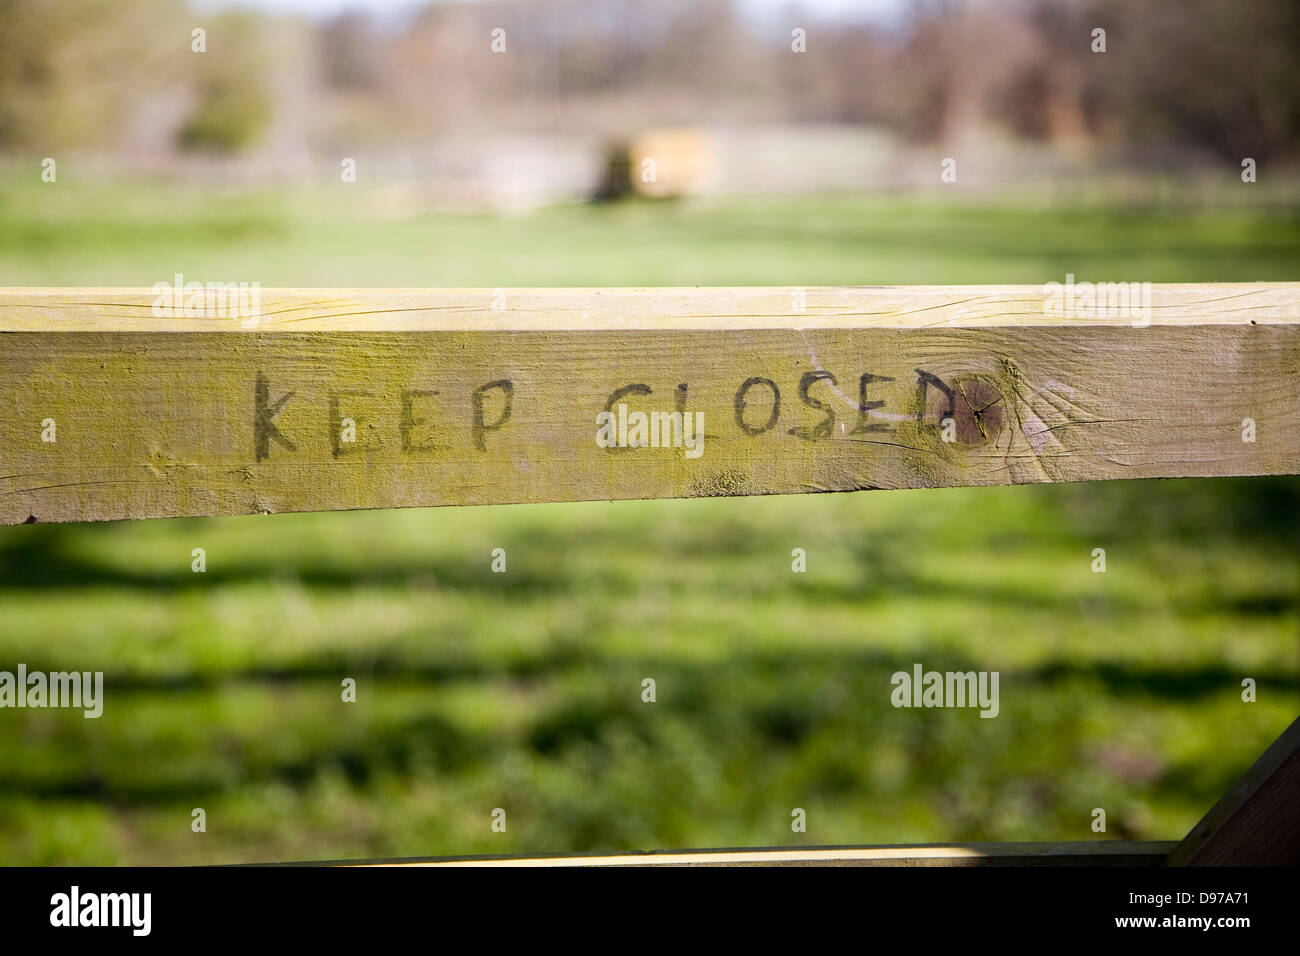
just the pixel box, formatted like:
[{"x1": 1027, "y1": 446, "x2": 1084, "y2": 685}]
[{"x1": 0, "y1": 0, "x2": 1300, "y2": 163}]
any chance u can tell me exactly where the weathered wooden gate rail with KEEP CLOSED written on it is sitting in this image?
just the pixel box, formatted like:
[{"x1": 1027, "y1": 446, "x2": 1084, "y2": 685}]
[{"x1": 0, "y1": 284, "x2": 1300, "y2": 523}]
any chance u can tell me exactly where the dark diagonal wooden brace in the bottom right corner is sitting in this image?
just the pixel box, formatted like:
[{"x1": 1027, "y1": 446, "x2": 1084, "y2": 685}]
[{"x1": 1167, "y1": 719, "x2": 1300, "y2": 866}]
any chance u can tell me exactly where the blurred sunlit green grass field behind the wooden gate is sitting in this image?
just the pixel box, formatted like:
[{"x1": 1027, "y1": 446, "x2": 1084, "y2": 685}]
[{"x1": 0, "y1": 175, "x2": 1300, "y2": 864}]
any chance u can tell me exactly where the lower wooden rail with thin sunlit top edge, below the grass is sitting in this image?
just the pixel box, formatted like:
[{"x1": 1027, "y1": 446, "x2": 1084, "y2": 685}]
[{"x1": 354, "y1": 840, "x2": 1178, "y2": 866}]
